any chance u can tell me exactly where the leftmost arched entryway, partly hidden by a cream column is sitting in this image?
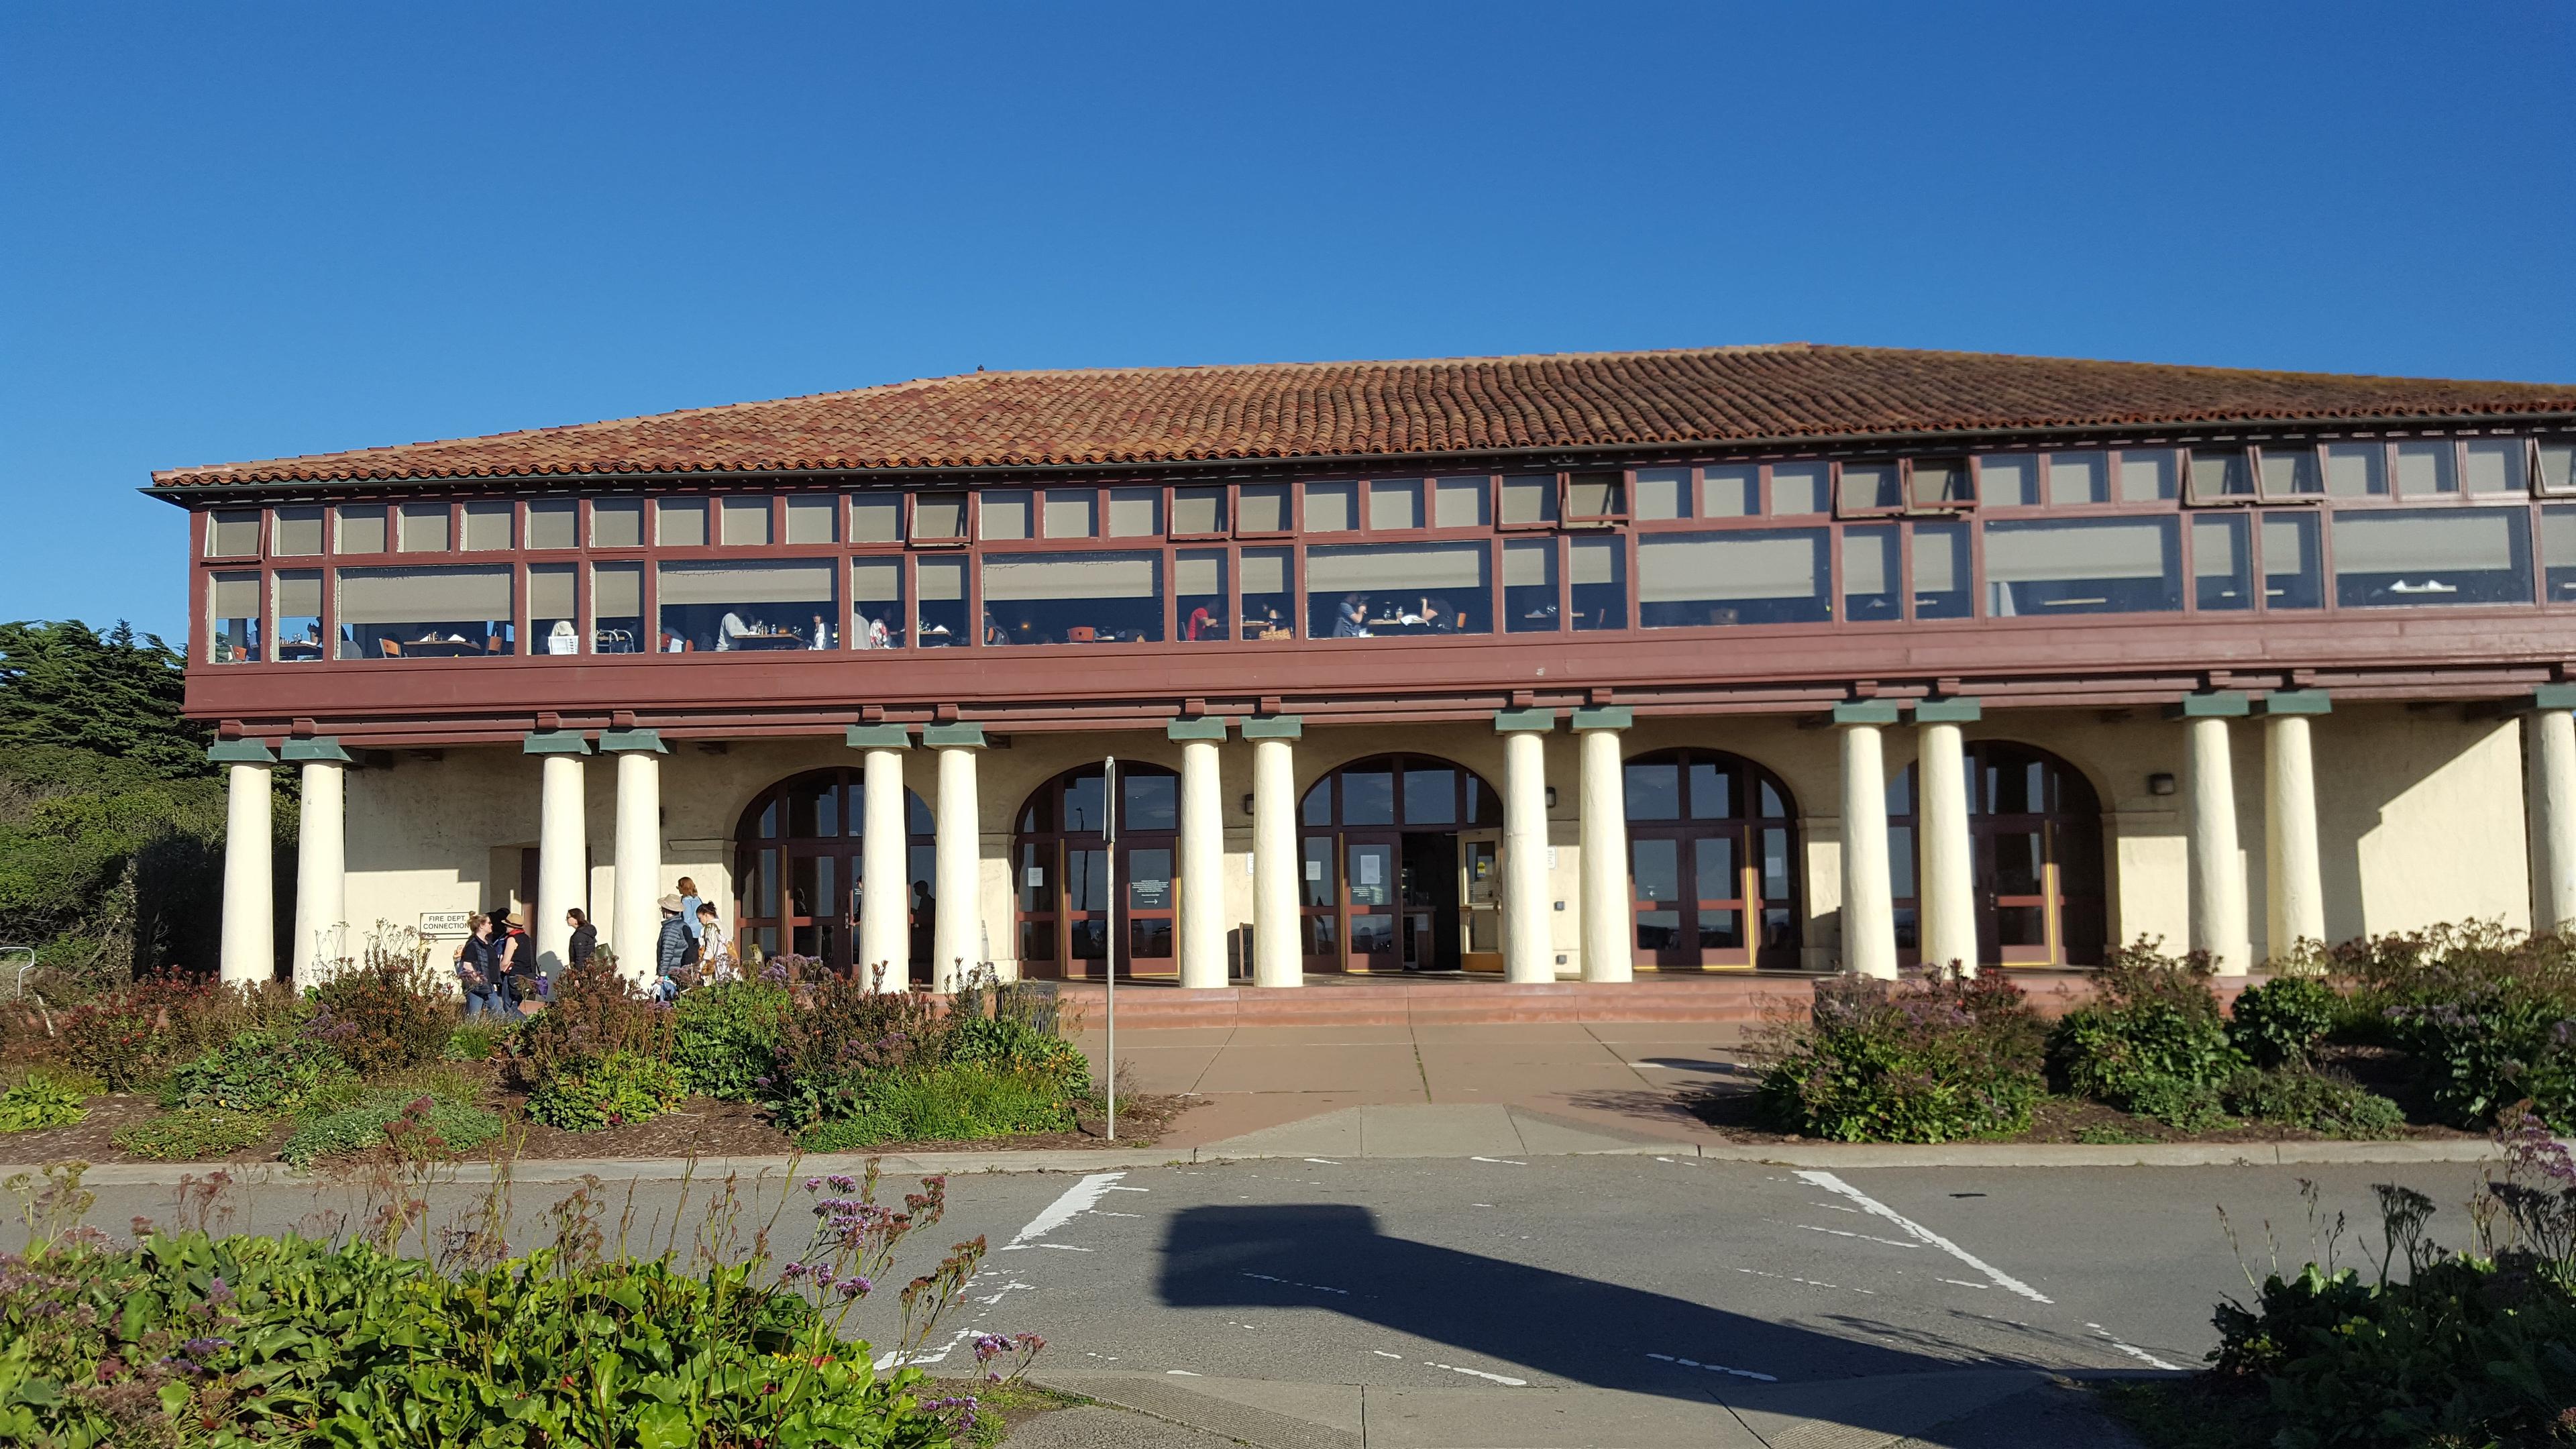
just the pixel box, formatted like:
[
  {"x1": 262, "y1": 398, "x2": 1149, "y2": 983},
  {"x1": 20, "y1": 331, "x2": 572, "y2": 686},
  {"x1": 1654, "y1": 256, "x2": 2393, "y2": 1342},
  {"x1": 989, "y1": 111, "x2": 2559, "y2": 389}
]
[{"x1": 734, "y1": 765, "x2": 938, "y2": 979}]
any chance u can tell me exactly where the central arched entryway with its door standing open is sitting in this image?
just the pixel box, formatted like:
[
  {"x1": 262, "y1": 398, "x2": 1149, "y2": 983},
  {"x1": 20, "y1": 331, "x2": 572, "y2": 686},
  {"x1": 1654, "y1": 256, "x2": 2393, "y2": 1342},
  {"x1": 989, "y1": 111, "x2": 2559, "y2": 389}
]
[{"x1": 1298, "y1": 755, "x2": 1502, "y2": 972}]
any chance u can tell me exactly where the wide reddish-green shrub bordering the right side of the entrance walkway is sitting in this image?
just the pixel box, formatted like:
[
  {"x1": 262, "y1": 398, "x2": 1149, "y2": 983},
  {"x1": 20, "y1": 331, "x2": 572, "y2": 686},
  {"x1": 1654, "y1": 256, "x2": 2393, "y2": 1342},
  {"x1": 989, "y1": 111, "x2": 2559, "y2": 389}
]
[{"x1": 1757, "y1": 972, "x2": 2045, "y2": 1142}]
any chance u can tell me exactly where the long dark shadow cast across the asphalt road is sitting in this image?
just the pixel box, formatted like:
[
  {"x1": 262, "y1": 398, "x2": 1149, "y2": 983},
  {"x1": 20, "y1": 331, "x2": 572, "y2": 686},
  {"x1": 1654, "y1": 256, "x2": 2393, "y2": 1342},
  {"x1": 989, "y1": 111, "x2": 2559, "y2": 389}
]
[{"x1": 1157, "y1": 1204, "x2": 2066, "y2": 1400}]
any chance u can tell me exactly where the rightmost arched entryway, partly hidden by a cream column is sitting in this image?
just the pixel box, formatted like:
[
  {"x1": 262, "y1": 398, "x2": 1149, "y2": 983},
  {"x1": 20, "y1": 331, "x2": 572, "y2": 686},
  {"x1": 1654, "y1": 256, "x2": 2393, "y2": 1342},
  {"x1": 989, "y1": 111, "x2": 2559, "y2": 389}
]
[{"x1": 1888, "y1": 740, "x2": 2110, "y2": 967}]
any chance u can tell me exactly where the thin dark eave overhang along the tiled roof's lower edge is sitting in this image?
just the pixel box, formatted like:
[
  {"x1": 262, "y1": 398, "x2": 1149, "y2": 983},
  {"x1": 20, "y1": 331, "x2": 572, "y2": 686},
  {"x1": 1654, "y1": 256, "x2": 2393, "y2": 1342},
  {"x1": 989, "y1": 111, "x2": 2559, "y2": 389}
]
[{"x1": 137, "y1": 407, "x2": 2576, "y2": 502}]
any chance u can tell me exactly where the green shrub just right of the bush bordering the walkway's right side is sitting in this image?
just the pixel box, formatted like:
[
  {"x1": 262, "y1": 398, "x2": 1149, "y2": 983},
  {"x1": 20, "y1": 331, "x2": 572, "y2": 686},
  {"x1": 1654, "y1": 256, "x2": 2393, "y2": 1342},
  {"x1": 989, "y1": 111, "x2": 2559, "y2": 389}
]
[{"x1": 2048, "y1": 941, "x2": 2246, "y2": 1132}]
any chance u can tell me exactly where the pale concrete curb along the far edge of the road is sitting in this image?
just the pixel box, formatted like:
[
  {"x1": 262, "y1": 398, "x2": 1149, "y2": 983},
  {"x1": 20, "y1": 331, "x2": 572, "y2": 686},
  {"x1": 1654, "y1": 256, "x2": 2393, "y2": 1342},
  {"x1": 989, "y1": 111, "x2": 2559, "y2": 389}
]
[{"x1": 0, "y1": 1137, "x2": 2534, "y2": 1186}]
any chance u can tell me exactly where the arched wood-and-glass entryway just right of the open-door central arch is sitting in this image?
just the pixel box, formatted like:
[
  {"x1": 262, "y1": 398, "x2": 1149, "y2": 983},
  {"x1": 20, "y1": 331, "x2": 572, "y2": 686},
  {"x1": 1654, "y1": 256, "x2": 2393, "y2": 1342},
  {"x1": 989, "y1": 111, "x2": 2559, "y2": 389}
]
[{"x1": 1623, "y1": 750, "x2": 1801, "y2": 972}]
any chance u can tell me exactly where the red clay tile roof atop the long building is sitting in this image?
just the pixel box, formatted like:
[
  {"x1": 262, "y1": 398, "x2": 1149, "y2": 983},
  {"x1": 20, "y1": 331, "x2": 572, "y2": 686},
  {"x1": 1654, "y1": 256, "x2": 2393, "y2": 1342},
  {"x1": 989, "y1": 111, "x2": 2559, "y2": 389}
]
[{"x1": 152, "y1": 343, "x2": 2576, "y2": 490}]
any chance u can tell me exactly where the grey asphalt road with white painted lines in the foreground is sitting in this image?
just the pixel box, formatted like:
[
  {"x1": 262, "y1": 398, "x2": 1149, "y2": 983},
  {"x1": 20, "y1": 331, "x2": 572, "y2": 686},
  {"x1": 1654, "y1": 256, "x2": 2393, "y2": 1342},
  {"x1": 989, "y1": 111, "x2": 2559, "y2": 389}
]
[{"x1": 20, "y1": 1158, "x2": 2478, "y2": 1397}]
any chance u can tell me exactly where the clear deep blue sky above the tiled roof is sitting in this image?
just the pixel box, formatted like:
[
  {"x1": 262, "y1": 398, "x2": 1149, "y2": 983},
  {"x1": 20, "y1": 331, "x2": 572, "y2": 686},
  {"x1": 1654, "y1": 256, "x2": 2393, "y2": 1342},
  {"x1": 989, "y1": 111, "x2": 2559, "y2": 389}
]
[{"x1": 0, "y1": 0, "x2": 2576, "y2": 634}]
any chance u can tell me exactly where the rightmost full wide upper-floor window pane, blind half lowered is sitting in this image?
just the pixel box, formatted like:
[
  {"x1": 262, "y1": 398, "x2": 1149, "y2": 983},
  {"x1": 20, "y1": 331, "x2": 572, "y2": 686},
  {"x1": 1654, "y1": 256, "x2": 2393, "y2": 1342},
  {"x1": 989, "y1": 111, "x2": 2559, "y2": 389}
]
[{"x1": 2334, "y1": 508, "x2": 2532, "y2": 608}]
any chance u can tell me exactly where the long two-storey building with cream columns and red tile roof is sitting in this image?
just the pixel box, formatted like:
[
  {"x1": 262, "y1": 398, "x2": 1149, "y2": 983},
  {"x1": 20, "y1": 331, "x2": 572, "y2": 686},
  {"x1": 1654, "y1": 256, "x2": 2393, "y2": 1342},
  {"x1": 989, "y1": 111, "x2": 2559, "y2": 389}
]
[{"x1": 152, "y1": 345, "x2": 2576, "y2": 987}]
